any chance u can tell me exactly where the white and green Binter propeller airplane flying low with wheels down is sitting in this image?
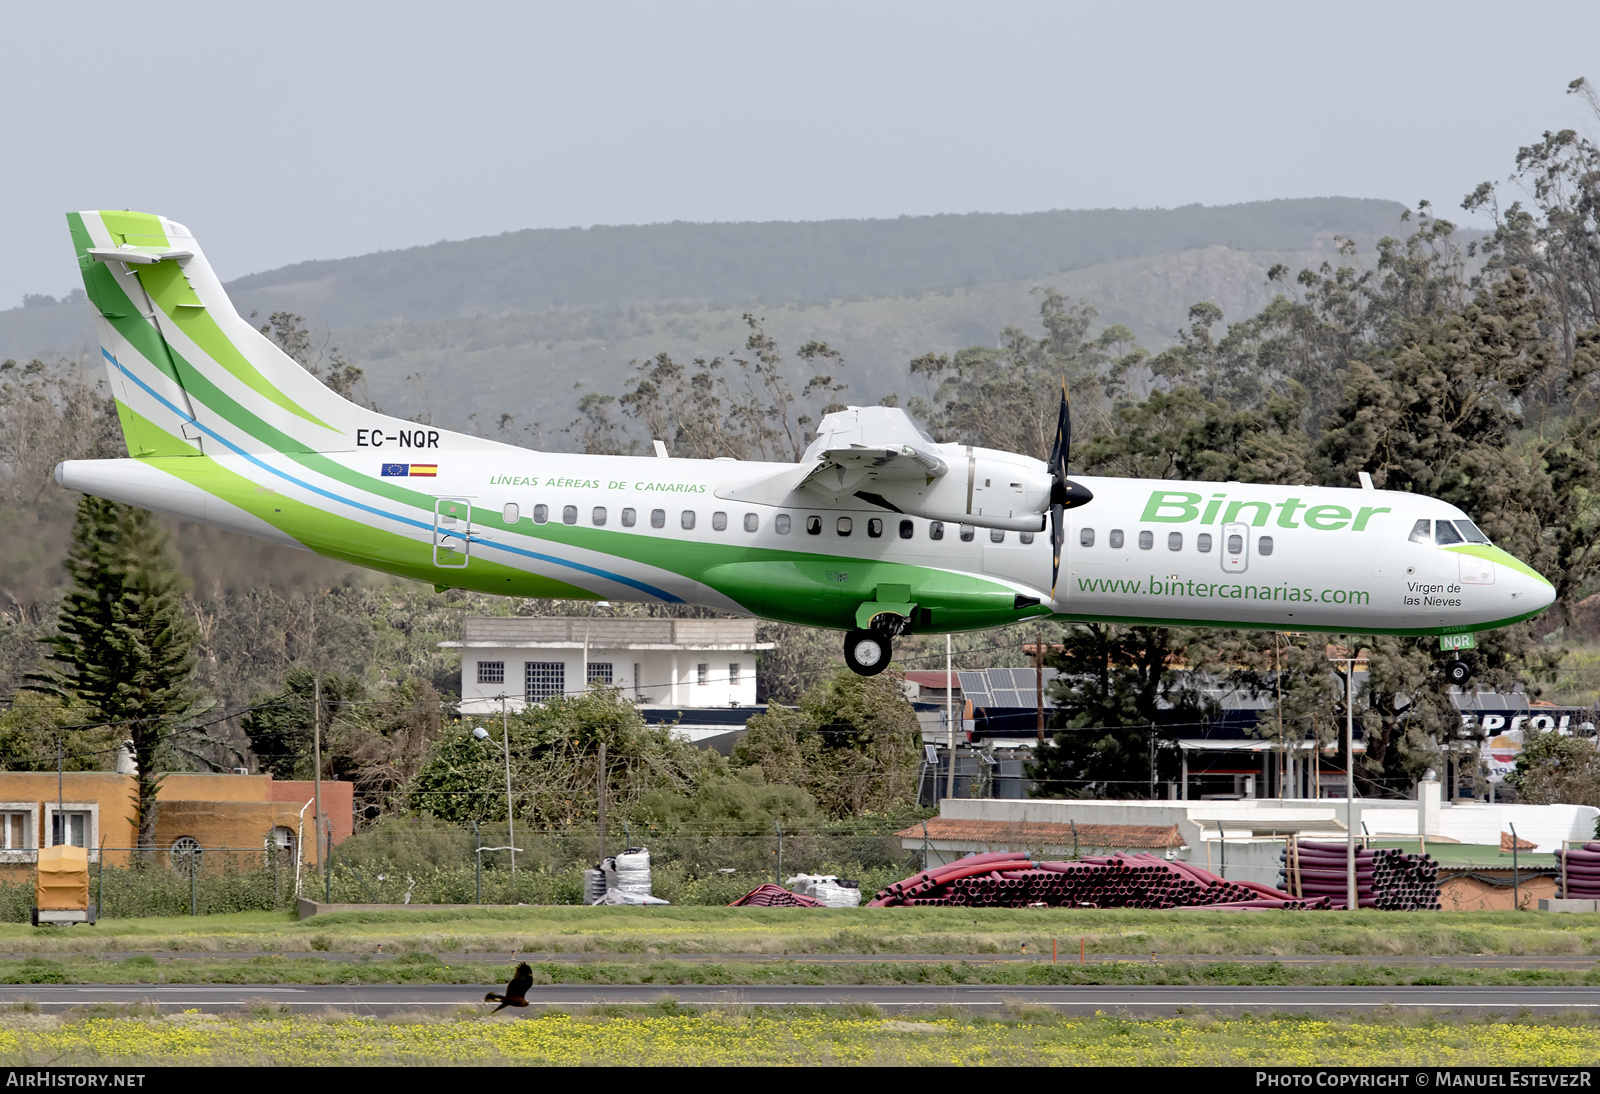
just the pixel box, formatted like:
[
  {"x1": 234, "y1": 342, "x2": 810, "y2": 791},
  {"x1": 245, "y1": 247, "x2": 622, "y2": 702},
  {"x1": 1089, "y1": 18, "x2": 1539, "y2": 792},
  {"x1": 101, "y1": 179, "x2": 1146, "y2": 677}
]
[{"x1": 56, "y1": 211, "x2": 1555, "y2": 675}]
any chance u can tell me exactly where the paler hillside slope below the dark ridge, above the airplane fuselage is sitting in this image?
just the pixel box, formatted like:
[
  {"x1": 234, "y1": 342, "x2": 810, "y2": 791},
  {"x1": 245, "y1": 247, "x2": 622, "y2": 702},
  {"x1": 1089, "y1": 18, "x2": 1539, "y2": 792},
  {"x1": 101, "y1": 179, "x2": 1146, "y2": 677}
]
[{"x1": 350, "y1": 246, "x2": 1322, "y2": 448}]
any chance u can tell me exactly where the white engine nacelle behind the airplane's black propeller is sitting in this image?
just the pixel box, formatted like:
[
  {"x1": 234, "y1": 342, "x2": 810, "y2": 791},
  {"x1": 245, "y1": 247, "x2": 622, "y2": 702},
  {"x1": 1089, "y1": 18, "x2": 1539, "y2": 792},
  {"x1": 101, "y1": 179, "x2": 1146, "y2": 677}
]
[{"x1": 858, "y1": 445, "x2": 1051, "y2": 531}]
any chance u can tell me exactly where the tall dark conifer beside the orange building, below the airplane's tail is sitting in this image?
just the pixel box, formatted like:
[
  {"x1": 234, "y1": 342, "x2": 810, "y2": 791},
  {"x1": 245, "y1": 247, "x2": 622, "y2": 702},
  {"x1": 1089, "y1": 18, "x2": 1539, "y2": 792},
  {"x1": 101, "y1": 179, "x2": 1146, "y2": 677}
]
[{"x1": 29, "y1": 496, "x2": 195, "y2": 848}]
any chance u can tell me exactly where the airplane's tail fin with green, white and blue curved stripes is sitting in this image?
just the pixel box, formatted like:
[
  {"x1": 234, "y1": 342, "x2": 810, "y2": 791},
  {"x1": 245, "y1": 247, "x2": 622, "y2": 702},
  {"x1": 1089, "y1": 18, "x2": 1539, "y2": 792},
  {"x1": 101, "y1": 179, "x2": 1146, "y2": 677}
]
[{"x1": 67, "y1": 210, "x2": 360, "y2": 456}]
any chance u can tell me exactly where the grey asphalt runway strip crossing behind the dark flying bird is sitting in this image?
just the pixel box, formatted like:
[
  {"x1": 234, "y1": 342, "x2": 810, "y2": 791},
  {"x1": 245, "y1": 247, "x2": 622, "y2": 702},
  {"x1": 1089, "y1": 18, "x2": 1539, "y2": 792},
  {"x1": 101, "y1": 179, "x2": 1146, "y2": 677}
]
[{"x1": 0, "y1": 984, "x2": 1600, "y2": 1016}]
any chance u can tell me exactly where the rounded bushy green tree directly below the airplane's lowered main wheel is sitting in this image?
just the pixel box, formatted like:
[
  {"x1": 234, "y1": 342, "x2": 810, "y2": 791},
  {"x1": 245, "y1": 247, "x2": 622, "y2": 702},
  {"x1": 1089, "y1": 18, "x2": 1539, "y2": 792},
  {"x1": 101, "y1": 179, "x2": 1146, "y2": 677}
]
[{"x1": 733, "y1": 670, "x2": 922, "y2": 817}]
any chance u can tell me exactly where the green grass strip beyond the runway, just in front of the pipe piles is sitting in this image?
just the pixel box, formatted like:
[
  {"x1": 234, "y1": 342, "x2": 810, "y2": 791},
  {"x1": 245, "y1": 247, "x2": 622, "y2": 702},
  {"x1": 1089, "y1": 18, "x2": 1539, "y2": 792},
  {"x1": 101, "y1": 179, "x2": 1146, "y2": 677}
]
[{"x1": 0, "y1": 907, "x2": 1600, "y2": 958}]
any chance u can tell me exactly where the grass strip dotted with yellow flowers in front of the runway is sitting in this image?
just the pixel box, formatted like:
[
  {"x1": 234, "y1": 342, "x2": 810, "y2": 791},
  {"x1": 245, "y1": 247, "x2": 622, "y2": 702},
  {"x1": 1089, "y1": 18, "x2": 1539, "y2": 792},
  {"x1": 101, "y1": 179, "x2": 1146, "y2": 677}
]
[{"x1": 0, "y1": 1001, "x2": 1600, "y2": 1067}]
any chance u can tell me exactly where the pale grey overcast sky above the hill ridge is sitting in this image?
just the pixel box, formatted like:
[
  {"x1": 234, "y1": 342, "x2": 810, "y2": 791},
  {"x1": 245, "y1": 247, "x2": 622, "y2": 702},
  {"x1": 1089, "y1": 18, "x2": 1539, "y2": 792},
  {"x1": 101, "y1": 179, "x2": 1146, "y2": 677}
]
[{"x1": 0, "y1": 0, "x2": 1600, "y2": 307}]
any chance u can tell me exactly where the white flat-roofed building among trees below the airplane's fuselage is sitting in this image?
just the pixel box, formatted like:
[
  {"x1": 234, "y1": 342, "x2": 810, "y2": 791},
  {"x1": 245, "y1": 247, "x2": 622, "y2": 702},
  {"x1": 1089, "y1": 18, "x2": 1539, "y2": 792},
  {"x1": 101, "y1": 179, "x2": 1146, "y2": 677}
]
[{"x1": 440, "y1": 616, "x2": 773, "y2": 715}]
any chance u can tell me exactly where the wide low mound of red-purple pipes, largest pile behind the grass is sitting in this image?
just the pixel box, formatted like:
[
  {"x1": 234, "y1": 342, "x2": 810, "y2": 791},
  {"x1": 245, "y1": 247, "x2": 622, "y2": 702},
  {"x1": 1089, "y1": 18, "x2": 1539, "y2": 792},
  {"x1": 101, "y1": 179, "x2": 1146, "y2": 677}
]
[{"x1": 867, "y1": 851, "x2": 1330, "y2": 910}]
